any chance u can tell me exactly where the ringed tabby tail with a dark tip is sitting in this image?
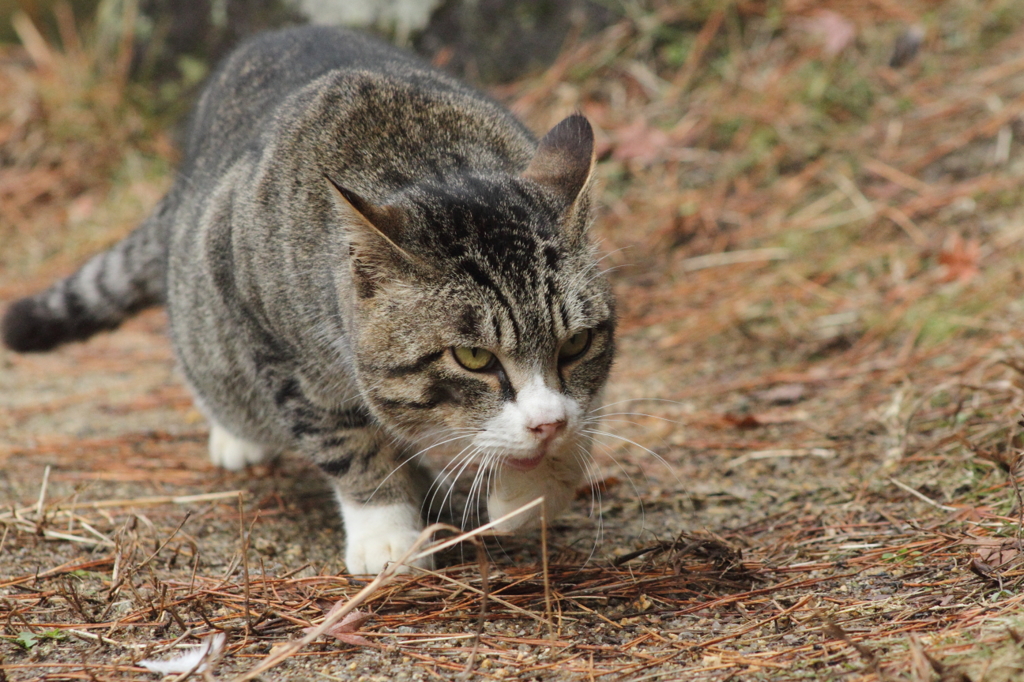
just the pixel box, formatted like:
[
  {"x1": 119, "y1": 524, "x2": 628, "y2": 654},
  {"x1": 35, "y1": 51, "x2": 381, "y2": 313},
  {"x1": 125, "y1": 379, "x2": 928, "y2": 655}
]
[{"x1": 0, "y1": 199, "x2": 167, "y2": 352}]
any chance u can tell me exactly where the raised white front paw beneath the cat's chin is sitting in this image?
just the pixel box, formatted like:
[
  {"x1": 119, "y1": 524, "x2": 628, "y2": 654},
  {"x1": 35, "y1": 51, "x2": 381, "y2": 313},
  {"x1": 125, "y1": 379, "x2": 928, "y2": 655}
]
[{"x1": 487, "y1": 457, "x2": 583, "y2": 531}]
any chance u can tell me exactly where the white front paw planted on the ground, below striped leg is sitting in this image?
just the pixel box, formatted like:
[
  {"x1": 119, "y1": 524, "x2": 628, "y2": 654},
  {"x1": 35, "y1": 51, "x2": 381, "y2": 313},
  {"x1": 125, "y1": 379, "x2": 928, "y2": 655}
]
[{"x1": 341, "y1": 500, "x2": 433, "y2": 576}]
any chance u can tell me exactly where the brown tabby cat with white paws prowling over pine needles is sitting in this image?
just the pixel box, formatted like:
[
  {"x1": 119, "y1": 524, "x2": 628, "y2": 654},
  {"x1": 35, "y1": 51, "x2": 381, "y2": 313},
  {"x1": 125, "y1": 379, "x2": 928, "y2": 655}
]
[{"x1": 0, "y1": 27, "x2": 615, "y2": 573}]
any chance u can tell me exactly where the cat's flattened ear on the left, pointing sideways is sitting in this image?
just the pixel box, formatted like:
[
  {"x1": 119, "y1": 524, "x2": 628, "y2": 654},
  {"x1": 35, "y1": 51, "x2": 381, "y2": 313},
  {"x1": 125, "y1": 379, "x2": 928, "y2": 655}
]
[{"x1": 324, "y1": 175, "x2": 419, "y2": 298}]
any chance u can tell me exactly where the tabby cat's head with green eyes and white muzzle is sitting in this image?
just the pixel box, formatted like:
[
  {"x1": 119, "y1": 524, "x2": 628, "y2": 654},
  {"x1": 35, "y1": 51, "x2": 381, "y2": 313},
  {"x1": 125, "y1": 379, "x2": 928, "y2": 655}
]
[{"x1": 336, "y1": 116, "x2": 615, "y2": 489}]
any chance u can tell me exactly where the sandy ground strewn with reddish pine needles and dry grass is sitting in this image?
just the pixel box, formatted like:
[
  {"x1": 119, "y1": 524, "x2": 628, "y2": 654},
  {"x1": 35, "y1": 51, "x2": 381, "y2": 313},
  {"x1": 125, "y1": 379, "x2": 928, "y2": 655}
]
[{"x1": 0, "y1": 1, "x2": 1024, "y2": 682}]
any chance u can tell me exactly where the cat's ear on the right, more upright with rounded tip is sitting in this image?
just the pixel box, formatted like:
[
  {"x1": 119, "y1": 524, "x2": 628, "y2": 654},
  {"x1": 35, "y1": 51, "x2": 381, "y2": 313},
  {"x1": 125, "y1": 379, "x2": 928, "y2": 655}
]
[{"x1": 522, "y1": 114, "x2": 594, "y2": 208}]
